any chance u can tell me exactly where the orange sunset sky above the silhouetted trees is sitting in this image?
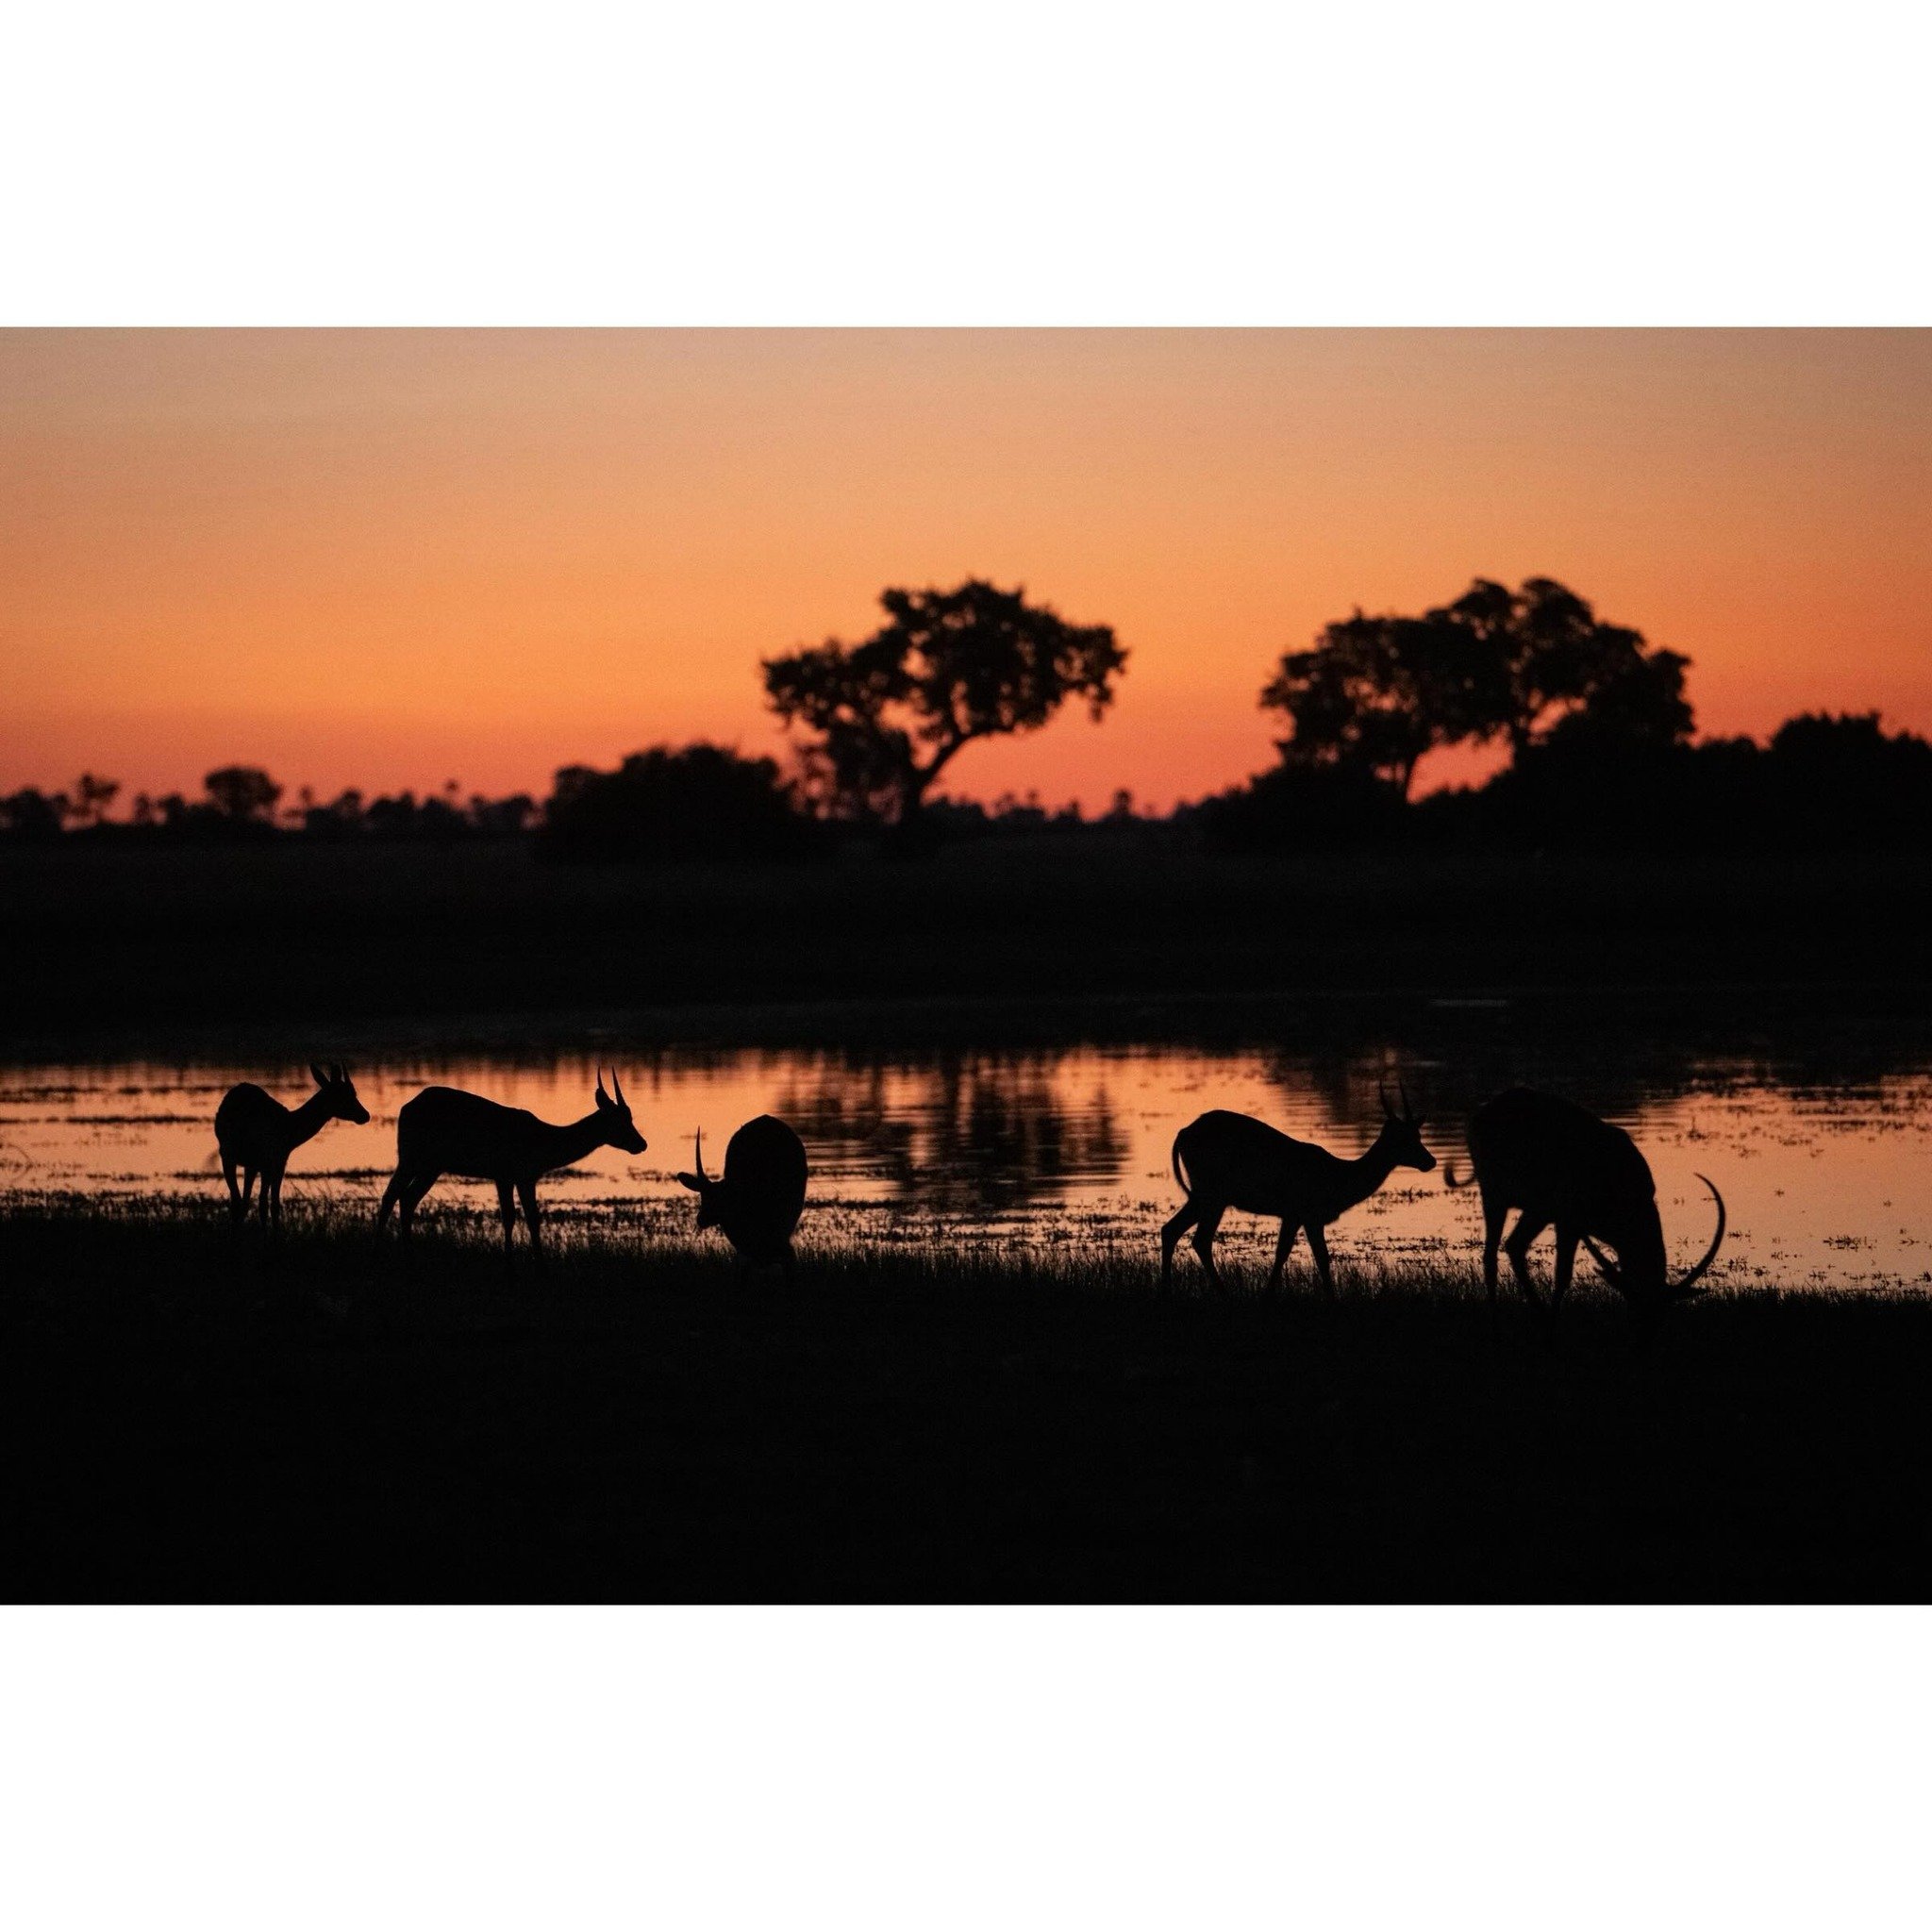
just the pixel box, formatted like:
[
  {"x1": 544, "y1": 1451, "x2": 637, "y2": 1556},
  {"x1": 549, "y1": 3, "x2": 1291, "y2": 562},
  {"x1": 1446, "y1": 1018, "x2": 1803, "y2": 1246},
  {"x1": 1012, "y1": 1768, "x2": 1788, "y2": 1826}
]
[{"x1": 0, "y1": 330, "x2": 1932, "y2": 806}]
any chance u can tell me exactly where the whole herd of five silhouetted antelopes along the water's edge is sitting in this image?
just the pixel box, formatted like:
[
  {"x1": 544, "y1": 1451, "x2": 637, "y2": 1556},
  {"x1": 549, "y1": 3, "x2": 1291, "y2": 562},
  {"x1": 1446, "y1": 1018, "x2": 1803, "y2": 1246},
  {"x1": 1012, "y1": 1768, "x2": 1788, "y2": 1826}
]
[{"x1": 214, "y1": 1064, "x2": 1725, "y2": 1325}]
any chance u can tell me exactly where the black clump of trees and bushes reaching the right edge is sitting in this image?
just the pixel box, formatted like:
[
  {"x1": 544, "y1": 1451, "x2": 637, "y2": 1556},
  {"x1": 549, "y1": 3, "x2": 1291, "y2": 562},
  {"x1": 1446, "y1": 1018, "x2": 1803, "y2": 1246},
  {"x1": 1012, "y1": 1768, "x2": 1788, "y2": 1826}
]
[{"x1": 1180, "y1": 577, "x2": 1932, "y2": 850}]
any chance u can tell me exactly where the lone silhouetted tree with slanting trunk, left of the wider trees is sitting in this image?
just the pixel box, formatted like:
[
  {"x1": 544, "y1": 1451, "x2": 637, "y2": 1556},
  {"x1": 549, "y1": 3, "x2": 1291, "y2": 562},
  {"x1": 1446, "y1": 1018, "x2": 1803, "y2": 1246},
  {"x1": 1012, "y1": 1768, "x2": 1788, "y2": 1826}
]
[{"x1": 763, "y1": 577, "x2": 1126, "y2": 824}]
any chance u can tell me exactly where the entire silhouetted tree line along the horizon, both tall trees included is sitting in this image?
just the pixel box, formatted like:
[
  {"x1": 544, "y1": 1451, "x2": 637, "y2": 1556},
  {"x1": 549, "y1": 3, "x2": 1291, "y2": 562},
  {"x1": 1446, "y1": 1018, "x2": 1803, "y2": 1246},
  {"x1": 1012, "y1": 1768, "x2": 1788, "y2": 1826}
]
[{"x1": 0, "y1": 577, "x2": 1932, "y2": 861}]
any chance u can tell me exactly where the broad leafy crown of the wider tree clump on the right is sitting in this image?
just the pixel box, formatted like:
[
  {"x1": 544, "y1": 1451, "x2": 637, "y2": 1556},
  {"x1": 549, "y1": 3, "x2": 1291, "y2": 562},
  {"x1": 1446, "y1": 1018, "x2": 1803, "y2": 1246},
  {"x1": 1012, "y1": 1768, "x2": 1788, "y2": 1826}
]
[{"x1": 1261, "y1": 577, "x2": 1694, "y2": 796}]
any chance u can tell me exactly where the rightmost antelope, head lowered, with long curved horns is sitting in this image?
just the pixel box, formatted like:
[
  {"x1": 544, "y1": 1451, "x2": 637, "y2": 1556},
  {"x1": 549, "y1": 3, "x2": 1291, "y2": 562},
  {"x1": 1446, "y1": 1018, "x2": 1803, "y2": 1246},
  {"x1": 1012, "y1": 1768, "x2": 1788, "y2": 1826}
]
[{"x1": 1443, "y1": 1088, "x2": 1724, "y2": 1327}]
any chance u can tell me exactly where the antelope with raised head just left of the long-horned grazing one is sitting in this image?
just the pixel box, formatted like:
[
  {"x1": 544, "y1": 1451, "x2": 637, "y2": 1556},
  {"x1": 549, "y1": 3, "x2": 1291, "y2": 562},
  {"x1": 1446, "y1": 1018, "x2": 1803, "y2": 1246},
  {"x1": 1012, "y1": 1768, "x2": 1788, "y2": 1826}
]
[{"x1": 1161, "y1": 1091, "x2": 1436, "y2": 1294}]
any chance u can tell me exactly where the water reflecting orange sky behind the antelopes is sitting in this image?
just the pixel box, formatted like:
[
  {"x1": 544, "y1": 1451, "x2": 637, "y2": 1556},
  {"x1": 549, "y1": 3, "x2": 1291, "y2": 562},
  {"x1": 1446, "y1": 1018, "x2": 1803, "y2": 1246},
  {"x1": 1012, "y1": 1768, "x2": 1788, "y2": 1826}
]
[{"x1": 0, "y1": 1045, "x2": 1932, "y2": 1289}]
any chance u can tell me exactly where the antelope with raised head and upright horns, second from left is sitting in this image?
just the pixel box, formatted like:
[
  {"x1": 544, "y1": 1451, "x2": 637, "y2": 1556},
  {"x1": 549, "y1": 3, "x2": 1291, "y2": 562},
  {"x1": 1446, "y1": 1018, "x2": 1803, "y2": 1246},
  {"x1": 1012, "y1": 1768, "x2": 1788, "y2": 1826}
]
[{"x1": 375, "y1": 1071, "x2": 645, "y2": 1256}]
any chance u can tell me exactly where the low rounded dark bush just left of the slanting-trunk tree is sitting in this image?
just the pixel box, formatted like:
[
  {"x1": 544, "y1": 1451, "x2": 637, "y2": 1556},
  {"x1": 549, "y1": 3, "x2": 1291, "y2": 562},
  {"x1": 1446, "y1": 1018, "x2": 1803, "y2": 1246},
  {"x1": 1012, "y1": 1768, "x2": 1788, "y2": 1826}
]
[{"x1": 539, "y1": 743, "x2": 811, "y2": 859}]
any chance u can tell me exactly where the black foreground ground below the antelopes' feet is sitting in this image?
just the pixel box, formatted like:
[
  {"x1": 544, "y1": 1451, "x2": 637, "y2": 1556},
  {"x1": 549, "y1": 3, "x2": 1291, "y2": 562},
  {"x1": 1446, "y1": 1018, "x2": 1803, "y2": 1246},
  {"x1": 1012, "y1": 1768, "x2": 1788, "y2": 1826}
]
[{"x1": 0, "y1": 1206, "x2": 1932, "y2": 1600}]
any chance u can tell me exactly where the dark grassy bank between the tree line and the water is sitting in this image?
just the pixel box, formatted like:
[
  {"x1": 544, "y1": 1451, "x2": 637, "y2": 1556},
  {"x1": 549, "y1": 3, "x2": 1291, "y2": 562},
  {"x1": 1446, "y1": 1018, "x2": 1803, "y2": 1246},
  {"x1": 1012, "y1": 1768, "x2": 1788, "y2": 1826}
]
[{"x1": 0, "y1": 829, "x2": 1932, "y2": 1043}]
